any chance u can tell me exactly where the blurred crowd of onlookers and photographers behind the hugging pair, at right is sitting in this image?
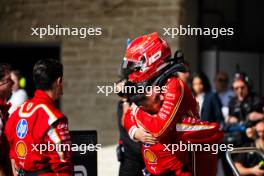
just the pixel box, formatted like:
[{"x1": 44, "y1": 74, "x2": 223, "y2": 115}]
[{"x1": 186, "y1": 71, "x2": 264, "y2": 175}]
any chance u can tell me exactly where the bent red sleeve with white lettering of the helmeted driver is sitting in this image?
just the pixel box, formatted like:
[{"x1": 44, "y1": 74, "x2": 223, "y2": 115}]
[{"x1": 134, "y1": 77, "x2": 184, "y2": 137}]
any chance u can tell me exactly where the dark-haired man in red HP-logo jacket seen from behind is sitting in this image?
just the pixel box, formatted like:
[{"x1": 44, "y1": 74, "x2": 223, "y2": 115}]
[{"x1": 5, "y1": 59, "x2": 72, "y2": 176}]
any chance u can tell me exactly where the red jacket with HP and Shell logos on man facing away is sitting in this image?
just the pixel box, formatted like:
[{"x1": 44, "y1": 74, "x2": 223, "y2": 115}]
[{"x1": 5, "y1": 90, "x2": 72, "y2": 176}]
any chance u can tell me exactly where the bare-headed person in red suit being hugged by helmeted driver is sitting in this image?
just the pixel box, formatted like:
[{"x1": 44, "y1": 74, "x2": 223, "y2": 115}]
[{"x1": 124, "y1": 85, "x2": 221, "y2": 176}]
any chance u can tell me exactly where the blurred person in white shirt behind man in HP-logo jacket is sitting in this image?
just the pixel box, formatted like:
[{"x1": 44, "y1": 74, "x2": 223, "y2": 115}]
[{"x1": 8, "y1": 70, "x2": 28, "y2": 114}]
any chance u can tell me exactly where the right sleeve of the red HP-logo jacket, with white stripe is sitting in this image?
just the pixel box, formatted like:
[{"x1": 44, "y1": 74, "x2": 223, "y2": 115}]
[{"x1": 44, "y1": 118, "x2": 72, "y2": 176}]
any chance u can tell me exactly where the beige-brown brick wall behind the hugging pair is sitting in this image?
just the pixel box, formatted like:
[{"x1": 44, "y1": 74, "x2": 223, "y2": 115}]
[{"x1": 0, "y1": 0, "x2": 194, "y2": 144}]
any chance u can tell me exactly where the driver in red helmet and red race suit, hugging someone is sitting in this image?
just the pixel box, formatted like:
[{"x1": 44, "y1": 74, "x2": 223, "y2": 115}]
[{"x1": 123, "y1": 33, "x2": 221, "y2": 176}]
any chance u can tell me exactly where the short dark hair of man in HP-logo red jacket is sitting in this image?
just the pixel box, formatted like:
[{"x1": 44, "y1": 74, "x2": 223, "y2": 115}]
[{"x1": 33, "y1": 59, "x2": 63, "y2": 90}]
